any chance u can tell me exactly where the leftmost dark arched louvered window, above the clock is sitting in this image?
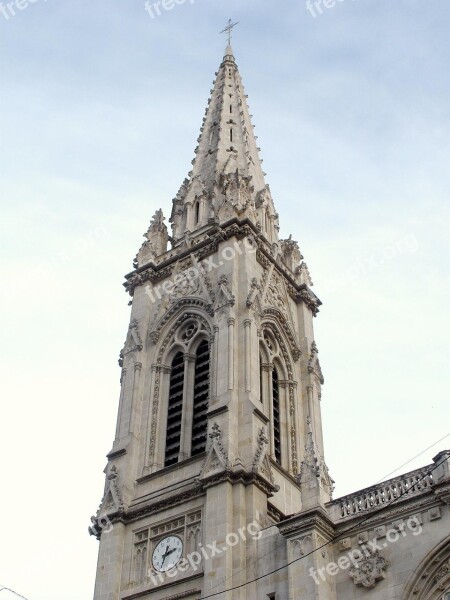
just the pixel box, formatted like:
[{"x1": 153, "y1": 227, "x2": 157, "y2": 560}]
[{"x1": 164, "y1": 352, "x2": 184, "y2": 467}]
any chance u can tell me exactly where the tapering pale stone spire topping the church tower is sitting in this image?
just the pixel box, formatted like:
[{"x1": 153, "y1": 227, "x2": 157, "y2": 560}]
[{"x1": 170, "y1": 45, "x2": 278, "y2": 245}]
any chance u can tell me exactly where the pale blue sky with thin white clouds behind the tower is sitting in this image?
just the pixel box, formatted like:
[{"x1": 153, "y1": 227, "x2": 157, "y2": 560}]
[{"x1": 0, "y1": 0, "x2": 450, "y2": 600}]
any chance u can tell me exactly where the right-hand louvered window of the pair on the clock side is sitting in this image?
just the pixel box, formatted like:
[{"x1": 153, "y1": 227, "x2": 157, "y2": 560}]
[{"x1": 191, "y1": 340, "x2": 209, "y2": 456}]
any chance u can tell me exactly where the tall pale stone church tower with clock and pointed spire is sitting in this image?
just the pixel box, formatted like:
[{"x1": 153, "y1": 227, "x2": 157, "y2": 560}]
[{"x1": 90, "y1": 46, "x2": 333, "y2": 600}]
